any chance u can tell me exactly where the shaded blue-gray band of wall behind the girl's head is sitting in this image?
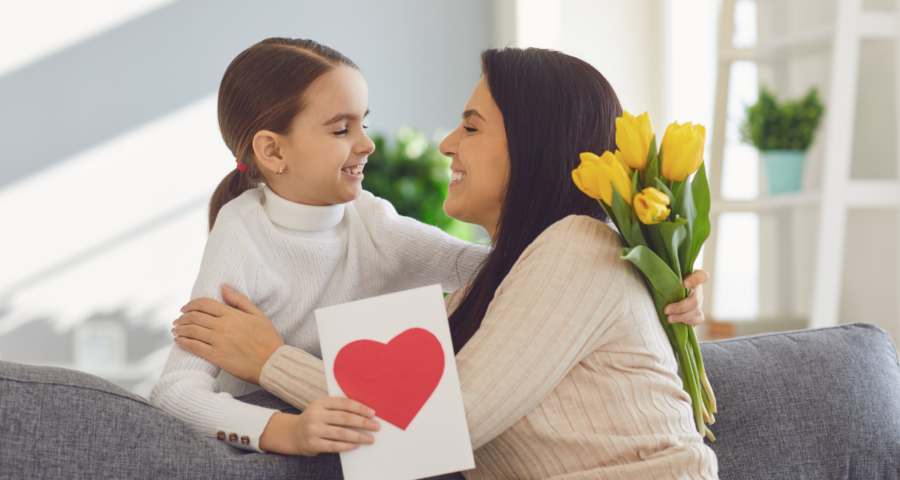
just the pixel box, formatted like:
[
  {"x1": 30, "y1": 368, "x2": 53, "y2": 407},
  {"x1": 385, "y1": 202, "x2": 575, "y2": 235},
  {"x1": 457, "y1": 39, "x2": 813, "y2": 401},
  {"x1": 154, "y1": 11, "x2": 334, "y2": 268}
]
[{"x1": 0, "y1": 0, "x2": 493, "y2": 188}]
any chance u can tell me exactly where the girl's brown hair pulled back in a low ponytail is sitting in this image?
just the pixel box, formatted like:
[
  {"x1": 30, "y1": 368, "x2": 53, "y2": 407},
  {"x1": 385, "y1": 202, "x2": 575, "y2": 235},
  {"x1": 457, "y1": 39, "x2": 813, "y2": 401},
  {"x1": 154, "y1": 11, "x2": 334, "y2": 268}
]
[{"x1": 209, "y1": 38, "x2": 358, "y2": 230}]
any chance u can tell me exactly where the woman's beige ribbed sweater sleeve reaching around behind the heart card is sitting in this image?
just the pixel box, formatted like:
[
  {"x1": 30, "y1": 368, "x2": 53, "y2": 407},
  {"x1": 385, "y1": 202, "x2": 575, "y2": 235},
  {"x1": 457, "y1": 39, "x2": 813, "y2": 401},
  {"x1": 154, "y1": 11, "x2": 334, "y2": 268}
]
[{"x1": 260, "y1": 217, "x2": 633, "y2": 449}]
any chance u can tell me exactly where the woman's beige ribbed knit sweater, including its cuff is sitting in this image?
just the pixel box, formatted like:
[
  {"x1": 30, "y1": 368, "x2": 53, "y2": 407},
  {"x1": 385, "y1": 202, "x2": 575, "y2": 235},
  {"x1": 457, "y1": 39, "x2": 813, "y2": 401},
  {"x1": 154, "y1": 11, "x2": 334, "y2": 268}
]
[{"x1": 260, "y1": 216, "x2": 718, "y2": 480}]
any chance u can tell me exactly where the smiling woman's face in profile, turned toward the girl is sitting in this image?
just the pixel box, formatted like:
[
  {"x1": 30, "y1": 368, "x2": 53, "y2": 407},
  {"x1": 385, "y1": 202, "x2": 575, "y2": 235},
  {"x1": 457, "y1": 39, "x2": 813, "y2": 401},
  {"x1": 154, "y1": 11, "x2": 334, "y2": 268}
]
[{"x1": 440, "y1": 78, "x2": 509, "y2": 238}]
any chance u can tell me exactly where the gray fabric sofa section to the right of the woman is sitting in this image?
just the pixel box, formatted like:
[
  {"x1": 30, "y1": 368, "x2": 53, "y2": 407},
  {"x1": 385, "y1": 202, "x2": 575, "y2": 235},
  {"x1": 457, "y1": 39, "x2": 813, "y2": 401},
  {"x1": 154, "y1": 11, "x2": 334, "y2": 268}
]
[{"x1": 701, "y1": 323, "x2": 900, "y2": 480}]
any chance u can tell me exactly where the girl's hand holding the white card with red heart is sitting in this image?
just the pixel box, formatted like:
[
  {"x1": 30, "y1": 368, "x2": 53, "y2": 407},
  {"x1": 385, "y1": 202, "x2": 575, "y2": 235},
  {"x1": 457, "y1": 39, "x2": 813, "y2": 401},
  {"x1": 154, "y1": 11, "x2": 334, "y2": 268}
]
[{"x1": 259, "y1": 397, "x2": 381, "y2": 457}]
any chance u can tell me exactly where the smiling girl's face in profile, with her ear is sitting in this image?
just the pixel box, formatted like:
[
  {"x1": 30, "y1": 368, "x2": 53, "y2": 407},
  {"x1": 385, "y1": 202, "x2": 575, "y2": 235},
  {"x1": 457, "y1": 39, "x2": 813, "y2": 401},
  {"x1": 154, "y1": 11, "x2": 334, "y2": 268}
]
[{"x1": 253, "y1": 66, "x2": 375, "y2": 206}]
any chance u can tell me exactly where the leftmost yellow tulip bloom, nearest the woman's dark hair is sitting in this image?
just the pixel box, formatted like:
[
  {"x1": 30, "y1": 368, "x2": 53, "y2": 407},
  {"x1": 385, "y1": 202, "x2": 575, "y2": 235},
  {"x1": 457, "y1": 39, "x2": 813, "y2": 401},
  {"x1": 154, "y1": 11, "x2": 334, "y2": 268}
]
[{"x1": 572, "y1": 152, "x2": 632, "y2": 205}]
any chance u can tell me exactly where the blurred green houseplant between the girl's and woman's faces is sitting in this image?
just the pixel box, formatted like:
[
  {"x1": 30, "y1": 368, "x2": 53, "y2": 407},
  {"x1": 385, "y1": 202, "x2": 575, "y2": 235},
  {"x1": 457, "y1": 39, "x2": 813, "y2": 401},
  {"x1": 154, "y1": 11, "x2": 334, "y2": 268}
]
[{"x1": 363, "y1": 128, "x2": 475, "y2": 241}]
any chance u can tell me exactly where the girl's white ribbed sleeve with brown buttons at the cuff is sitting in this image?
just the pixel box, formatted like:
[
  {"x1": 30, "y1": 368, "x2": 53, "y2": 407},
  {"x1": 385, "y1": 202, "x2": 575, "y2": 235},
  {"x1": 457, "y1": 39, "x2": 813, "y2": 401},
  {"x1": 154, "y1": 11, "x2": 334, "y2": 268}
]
[{"x1": 150, "y1": 224, "x2": 276, "y2": 452}]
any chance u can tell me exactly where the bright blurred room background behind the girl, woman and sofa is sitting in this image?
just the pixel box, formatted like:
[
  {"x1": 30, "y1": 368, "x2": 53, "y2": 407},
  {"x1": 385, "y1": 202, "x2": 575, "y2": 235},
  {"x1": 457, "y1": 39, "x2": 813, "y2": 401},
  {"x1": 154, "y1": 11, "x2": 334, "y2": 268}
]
[{"x1": 0, "y1": 0, "x2": 900, "y2": 396}]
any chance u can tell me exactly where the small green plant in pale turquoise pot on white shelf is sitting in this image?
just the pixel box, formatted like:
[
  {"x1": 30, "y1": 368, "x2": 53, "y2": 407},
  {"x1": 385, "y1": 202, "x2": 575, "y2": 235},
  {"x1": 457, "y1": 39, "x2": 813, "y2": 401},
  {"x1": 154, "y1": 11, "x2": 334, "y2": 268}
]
[{"x1": 741, "y1": 87, "x2": 825, "y2": 195}]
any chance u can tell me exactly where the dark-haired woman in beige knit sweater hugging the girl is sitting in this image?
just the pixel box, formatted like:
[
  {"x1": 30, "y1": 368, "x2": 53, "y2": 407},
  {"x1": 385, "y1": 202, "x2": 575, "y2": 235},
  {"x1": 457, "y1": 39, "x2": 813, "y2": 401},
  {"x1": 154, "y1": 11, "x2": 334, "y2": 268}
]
[{"x1": 174, "y1": 49, "x2": 717, "y2": 479}]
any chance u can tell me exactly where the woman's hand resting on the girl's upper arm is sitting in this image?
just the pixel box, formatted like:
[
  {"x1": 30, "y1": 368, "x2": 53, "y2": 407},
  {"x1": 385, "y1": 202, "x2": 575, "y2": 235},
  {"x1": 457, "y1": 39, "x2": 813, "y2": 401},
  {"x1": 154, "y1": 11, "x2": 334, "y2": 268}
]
[{"x1": 172, "y1": 285, "x2": 284, "y2": 385}]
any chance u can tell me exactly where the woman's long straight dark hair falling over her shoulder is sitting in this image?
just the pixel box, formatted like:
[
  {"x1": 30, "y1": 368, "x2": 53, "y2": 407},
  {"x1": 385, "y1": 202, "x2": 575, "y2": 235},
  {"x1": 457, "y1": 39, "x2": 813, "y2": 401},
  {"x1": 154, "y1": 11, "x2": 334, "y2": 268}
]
[{"x1": 450, "y1": 48, "x2": 622, "y2": 353}]
